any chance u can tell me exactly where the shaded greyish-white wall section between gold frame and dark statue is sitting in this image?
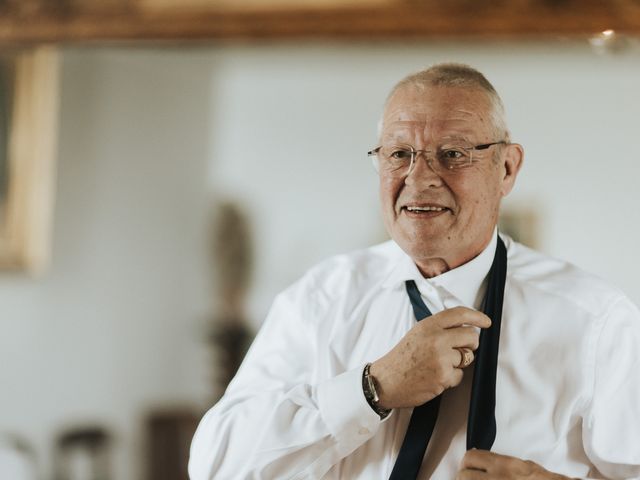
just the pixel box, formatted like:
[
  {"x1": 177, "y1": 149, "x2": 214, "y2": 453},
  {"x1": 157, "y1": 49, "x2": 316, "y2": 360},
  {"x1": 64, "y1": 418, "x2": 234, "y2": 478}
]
[{"x1": 0, "y1": 50, "x2": 215, "y2": 480}]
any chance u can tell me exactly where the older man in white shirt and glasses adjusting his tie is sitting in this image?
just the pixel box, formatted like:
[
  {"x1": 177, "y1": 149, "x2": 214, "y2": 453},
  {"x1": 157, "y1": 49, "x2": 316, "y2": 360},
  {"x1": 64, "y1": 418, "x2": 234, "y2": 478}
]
[{"x1": 189, "y1": 64, "x2": 640, "y2": 480}]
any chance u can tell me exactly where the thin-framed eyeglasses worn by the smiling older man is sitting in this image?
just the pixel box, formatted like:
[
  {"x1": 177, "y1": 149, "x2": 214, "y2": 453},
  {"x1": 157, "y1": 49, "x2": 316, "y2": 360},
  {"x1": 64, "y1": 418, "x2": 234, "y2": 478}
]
[{"x1": 367, "y1": 140, "x2": 507, "y2": 177}]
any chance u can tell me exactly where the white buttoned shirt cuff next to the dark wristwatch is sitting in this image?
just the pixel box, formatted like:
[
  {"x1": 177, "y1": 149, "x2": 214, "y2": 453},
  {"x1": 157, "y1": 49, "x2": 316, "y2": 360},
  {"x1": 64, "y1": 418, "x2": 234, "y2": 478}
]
[{"x1": 317, "y1": 364, "x2": 389, "y2": 455}]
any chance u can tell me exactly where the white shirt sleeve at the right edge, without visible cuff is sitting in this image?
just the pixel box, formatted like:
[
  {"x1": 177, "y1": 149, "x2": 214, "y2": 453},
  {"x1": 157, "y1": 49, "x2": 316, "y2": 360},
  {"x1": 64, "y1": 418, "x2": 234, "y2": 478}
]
[{"x1": 583, "y1": 298, "x2": 640, "y2": 480}]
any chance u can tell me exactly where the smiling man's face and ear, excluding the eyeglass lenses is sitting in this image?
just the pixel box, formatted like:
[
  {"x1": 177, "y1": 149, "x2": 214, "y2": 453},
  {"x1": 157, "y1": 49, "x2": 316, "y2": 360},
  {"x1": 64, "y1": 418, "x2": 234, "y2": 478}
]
[{"x1": 380, "y1": 86, "x2": 522, "y2": 276}]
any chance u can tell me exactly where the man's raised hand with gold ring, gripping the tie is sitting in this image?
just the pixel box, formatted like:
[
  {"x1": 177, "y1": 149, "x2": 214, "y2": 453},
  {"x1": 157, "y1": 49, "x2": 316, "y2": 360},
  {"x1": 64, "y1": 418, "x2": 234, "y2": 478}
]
[{"x1": 370, "y1": 307, "x2": 491, "y2": 408}]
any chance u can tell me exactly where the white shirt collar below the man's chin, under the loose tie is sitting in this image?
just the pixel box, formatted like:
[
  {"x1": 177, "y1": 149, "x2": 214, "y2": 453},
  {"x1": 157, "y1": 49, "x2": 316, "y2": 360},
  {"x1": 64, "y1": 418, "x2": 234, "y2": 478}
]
[{"x1": 383, "y1": 229, "x2": 498, "y2": 308}]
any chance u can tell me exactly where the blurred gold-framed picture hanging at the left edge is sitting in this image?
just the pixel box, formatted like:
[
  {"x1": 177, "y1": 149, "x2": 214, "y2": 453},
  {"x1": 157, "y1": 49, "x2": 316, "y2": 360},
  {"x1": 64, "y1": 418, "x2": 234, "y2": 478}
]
[{"x1": 0, "y1": 47, "x2": 59, "y2": 274}]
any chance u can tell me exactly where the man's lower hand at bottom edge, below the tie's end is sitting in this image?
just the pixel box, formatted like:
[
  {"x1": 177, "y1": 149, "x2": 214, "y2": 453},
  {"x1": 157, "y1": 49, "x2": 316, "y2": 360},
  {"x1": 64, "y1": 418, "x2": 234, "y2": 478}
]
[{"x1": 456, "y1": 450, "x2": 569, "y2": 480}]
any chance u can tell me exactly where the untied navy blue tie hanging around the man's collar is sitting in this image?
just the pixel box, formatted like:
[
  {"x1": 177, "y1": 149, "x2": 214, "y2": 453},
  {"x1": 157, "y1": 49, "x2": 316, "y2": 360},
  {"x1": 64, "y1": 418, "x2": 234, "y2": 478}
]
[{"x1": 389, "y1": 236, "x2": 507, "y2": 480}]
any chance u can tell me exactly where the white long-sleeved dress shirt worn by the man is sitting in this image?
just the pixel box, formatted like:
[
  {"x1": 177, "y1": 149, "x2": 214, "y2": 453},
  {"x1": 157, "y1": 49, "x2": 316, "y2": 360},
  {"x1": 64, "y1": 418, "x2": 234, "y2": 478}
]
[{"x1": 189, "y1": 234, "x2": 640, "y2": 480}]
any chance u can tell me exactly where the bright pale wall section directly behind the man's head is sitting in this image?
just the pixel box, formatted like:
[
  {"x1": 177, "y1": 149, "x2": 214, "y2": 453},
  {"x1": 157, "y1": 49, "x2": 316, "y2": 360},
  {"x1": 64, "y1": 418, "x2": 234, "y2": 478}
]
[{"x1": 210, "y1": 42, "x2": 640, "y2": 321}]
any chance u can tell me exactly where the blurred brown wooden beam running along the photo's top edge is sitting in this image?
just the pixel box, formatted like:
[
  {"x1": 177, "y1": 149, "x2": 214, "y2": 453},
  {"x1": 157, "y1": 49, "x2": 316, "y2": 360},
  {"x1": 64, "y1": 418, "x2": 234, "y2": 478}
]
[{"x1": 0, "y1": 0, "x2": 640, "y2": 45}]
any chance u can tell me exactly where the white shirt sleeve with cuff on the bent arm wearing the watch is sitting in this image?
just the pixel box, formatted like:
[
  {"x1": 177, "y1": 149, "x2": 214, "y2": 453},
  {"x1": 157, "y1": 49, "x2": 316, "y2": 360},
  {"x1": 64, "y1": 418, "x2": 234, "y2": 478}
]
[{"x1": 189, "y1": 282, "x2": 380, "y2": 480}]
